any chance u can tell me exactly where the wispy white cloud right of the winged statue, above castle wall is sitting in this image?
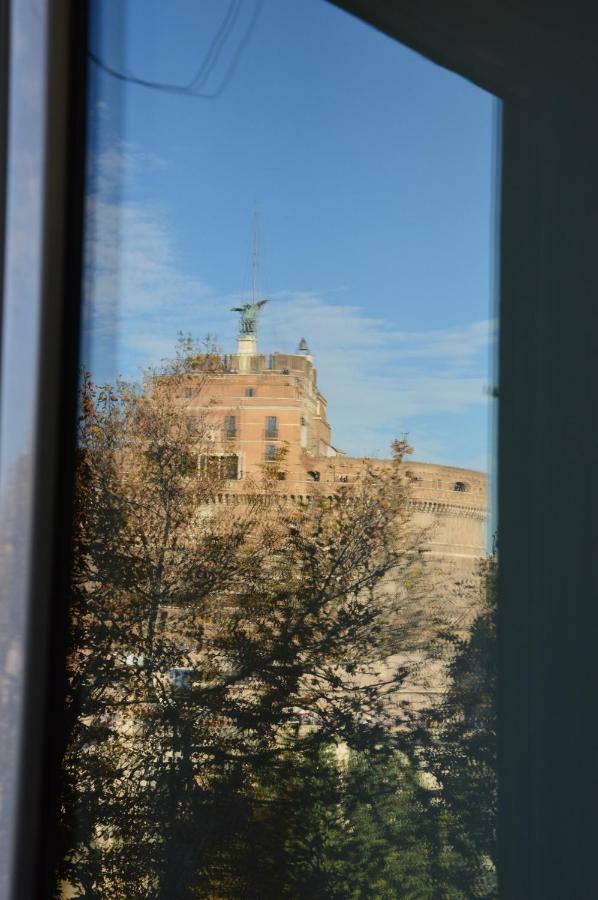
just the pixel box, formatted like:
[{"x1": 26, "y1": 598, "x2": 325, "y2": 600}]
[{"x1": 262, "y1": 292, "x2": 496, "y2": 455}]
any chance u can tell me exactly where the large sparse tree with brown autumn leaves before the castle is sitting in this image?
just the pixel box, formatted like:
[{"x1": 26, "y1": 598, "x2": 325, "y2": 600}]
[{"x1": 57, "y1": 339, "x2": 432, "y2": 900}]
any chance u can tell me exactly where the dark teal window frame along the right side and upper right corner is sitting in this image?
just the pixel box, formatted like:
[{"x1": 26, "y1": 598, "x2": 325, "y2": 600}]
[{"x1": 329, "y1": 0, "x2": 598, "y2": 900}]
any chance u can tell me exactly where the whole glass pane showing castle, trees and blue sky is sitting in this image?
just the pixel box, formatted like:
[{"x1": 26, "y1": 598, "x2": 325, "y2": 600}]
[{"x1": 57, "y1": 0, "x2": 496, "y2": 898}]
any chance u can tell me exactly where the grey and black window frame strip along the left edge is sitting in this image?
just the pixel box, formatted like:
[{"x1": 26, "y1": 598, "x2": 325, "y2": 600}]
[{"x1": 0, "y1": 0, "x2": 88, "y2": 900}]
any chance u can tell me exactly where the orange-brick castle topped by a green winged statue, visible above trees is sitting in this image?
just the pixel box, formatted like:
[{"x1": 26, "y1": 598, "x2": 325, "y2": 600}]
[{"x1": 170, "y1": 301, "x2": 487, "y2": 707}]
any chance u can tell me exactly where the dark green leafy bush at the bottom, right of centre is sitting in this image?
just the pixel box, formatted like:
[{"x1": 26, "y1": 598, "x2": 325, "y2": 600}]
[{"x1": 234, "y1": 745, "x2": 466, "y2": 900}]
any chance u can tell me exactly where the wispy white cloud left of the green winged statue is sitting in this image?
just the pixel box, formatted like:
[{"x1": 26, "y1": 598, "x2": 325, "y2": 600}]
[{"x1": 84, "y1": 146, "x2": 210, "y2": 370}]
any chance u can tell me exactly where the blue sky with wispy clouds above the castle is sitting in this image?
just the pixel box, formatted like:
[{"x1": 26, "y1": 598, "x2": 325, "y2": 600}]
[{"x1": 83, "y1": 0, "x2": 498, "y2": 471}]
